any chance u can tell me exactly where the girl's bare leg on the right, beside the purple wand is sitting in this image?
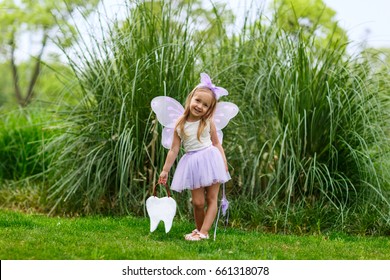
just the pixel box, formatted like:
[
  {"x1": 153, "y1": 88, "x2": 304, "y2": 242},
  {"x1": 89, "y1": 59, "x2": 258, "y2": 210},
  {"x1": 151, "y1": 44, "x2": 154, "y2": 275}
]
[{"x1": 200, "y1": 183, "x2": 220, "y2": 235}]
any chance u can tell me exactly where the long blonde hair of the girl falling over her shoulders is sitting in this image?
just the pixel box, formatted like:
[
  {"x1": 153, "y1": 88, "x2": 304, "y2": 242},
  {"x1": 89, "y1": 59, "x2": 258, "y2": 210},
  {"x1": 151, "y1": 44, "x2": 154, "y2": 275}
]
[{"x1": 175, "y1": 86, "x2": 217, "y2": 141}]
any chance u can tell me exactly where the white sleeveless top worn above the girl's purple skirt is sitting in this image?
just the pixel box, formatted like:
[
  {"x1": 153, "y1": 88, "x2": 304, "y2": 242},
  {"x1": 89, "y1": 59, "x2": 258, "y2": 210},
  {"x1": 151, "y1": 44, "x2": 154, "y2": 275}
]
[{"x1": 177, "y1": 120, "x2": 213, "y2": 152}]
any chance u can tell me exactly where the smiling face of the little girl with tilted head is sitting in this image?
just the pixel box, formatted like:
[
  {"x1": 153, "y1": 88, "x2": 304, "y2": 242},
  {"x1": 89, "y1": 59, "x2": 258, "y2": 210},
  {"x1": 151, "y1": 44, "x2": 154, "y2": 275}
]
[{"x1": 188, "y1": 89, "x2": 214, "y2": 121}]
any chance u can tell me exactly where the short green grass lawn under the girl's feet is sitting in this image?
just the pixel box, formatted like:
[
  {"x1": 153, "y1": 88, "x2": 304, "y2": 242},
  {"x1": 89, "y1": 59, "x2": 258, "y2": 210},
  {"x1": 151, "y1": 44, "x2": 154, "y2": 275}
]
[{"x1": 0, "y1": 210, "x2": 390, "y2": 260}]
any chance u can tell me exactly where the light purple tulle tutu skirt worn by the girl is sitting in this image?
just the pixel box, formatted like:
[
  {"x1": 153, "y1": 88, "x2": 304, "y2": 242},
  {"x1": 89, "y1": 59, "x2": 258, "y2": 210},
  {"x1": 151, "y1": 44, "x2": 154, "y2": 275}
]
[{"x1": 171, "y1": 146, "x2": 231, "y2": 192}]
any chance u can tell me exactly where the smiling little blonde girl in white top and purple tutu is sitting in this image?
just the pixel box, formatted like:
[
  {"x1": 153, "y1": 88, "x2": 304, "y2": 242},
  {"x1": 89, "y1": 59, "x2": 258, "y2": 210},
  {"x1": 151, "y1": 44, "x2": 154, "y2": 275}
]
[{"x1": 159, "y1": 74, "x2": 230, "y2": 241}]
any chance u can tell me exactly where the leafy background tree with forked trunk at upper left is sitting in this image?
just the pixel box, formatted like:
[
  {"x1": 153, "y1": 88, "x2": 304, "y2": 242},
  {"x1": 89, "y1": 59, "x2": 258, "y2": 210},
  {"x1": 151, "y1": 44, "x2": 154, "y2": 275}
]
[{"x1": 0, "y1": 0, "x2": 100, "y2": 106}]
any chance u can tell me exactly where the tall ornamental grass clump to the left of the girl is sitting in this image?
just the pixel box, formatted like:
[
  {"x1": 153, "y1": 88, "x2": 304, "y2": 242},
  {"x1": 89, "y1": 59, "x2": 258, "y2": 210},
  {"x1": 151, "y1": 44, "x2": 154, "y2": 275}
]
[{"x1": 48, "y1": 3, "x2": 199, "y2": 214}]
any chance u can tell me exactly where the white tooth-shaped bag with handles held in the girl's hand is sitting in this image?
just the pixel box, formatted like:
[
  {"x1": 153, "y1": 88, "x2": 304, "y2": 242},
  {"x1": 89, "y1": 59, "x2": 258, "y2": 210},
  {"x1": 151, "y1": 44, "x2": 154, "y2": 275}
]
[{"x1": 146, "y1": 185, "x2": 176, "y2": 233}]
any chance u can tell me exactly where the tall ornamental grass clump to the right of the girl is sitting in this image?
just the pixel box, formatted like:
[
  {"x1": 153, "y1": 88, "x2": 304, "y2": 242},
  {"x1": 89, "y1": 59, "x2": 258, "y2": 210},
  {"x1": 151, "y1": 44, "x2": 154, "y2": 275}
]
[{"x1": 210, "y1": 17, "x2": 390, "y2": 233}]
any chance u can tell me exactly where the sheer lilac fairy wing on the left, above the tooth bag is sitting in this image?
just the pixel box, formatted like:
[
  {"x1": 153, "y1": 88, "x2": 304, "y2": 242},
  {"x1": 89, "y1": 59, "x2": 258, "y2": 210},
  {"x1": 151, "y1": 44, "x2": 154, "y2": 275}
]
[{"x1": 151, "y1": 96, "x2": 184, "y2": 149}]
